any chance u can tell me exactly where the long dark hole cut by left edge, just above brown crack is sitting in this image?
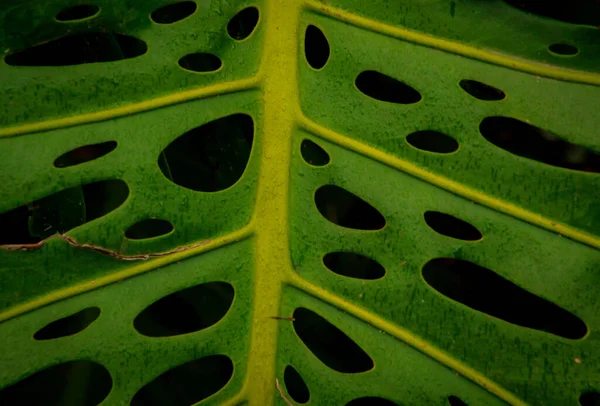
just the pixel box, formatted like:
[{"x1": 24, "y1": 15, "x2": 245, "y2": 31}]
[{"x1": 0, "y1": 179, "x2": 129, "y2": 244}]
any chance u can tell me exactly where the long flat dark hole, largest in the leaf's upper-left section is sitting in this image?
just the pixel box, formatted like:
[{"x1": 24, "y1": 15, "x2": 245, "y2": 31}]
[{"x1": 4, "y1": 32, "x2": 148, "y2": 66}]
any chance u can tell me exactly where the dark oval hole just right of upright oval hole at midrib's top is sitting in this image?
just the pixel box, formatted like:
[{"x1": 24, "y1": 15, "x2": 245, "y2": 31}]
[{"x1": 355, "y1": 70, "x2": 421, "y2": 104}]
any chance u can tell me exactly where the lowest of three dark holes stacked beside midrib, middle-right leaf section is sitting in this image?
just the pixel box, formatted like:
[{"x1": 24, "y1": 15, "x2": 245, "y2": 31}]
[{"x1": 323, "y1": 252, "x2": 385, "y2": 280}]
